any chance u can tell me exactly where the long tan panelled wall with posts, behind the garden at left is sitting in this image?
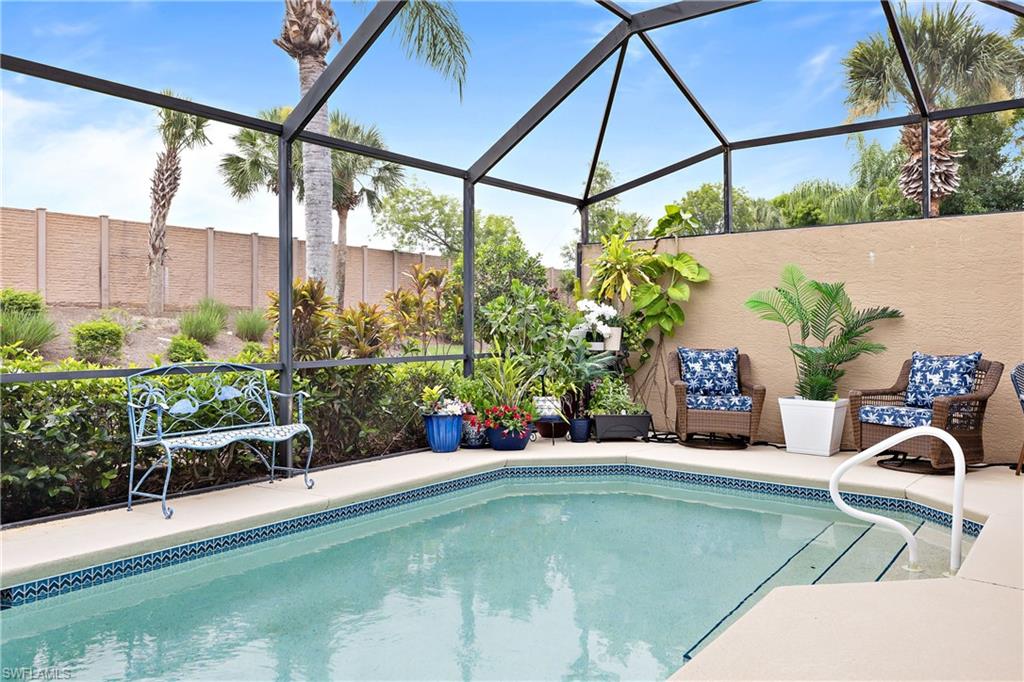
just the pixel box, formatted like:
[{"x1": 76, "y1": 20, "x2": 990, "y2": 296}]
[{"x1": 0, "y1": 207, "x2": 450, "y2": 310}]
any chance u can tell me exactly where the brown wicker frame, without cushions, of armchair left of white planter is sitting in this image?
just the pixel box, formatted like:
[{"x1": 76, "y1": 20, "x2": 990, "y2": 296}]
[{"x1": 667, "y1": 350, "x2": 765, "y2": 442}]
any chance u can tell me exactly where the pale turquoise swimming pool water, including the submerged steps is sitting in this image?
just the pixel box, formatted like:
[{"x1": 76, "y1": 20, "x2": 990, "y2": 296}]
[{"x1": 0, "y1": 478, "x2": 969, "y2": 680}]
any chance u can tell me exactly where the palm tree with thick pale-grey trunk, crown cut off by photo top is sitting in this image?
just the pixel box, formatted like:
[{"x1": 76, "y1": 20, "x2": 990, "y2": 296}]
[{"x1": 273, "y1": 0, "x2": 469, "y2": 288}]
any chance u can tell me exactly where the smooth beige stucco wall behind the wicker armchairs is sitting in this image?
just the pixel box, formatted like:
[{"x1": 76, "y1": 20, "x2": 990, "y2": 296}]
[{"x1": 584, "y1": 213, "x2": 1024, "y2": 461}]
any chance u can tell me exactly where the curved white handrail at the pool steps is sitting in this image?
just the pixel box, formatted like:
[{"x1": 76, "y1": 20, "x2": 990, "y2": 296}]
[{"x1": 828, "y1": 426, "x2": 967, "y2": 574}]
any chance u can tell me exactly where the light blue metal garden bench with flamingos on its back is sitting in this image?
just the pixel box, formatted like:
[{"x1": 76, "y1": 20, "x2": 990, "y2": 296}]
[{"x1": 127, "y1": 363, "x2": 313, "y2": 518}]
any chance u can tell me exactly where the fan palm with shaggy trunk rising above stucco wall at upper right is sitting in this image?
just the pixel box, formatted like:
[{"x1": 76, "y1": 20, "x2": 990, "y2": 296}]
[{"x1": 843, "y1": 1, "x2": 1024, "y2": 215}]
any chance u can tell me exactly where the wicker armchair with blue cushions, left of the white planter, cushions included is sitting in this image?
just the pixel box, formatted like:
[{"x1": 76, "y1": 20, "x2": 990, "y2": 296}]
[{"x1": 668, "y1": 347, "x2": 765, "y2": 442}]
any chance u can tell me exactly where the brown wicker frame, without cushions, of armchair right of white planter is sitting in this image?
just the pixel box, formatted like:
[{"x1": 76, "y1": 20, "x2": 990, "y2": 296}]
[{"x1": 850, "y1": 359, "x2": 1002, "y2": 469}]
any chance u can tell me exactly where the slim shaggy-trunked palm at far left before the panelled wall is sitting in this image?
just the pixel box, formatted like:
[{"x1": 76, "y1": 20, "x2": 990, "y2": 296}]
[{"x1": 148, "y1": 90, "x2": 210, "y2": 315}]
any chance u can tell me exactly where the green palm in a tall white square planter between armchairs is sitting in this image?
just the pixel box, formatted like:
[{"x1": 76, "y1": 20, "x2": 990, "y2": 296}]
[{"x1": 745, "y1": 264, "x2": 903, "y2": 457}]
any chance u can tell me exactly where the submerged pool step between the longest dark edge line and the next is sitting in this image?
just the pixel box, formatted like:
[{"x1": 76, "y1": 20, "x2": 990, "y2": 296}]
[{"x1": 684, "y1": 521, "x2": 868, "y2": 660}]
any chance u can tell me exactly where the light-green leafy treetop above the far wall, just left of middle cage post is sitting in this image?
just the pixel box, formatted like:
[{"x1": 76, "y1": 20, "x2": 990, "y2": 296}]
[{"x1": 375, "y1": 183, "x2": 462, "y2": 259}]
